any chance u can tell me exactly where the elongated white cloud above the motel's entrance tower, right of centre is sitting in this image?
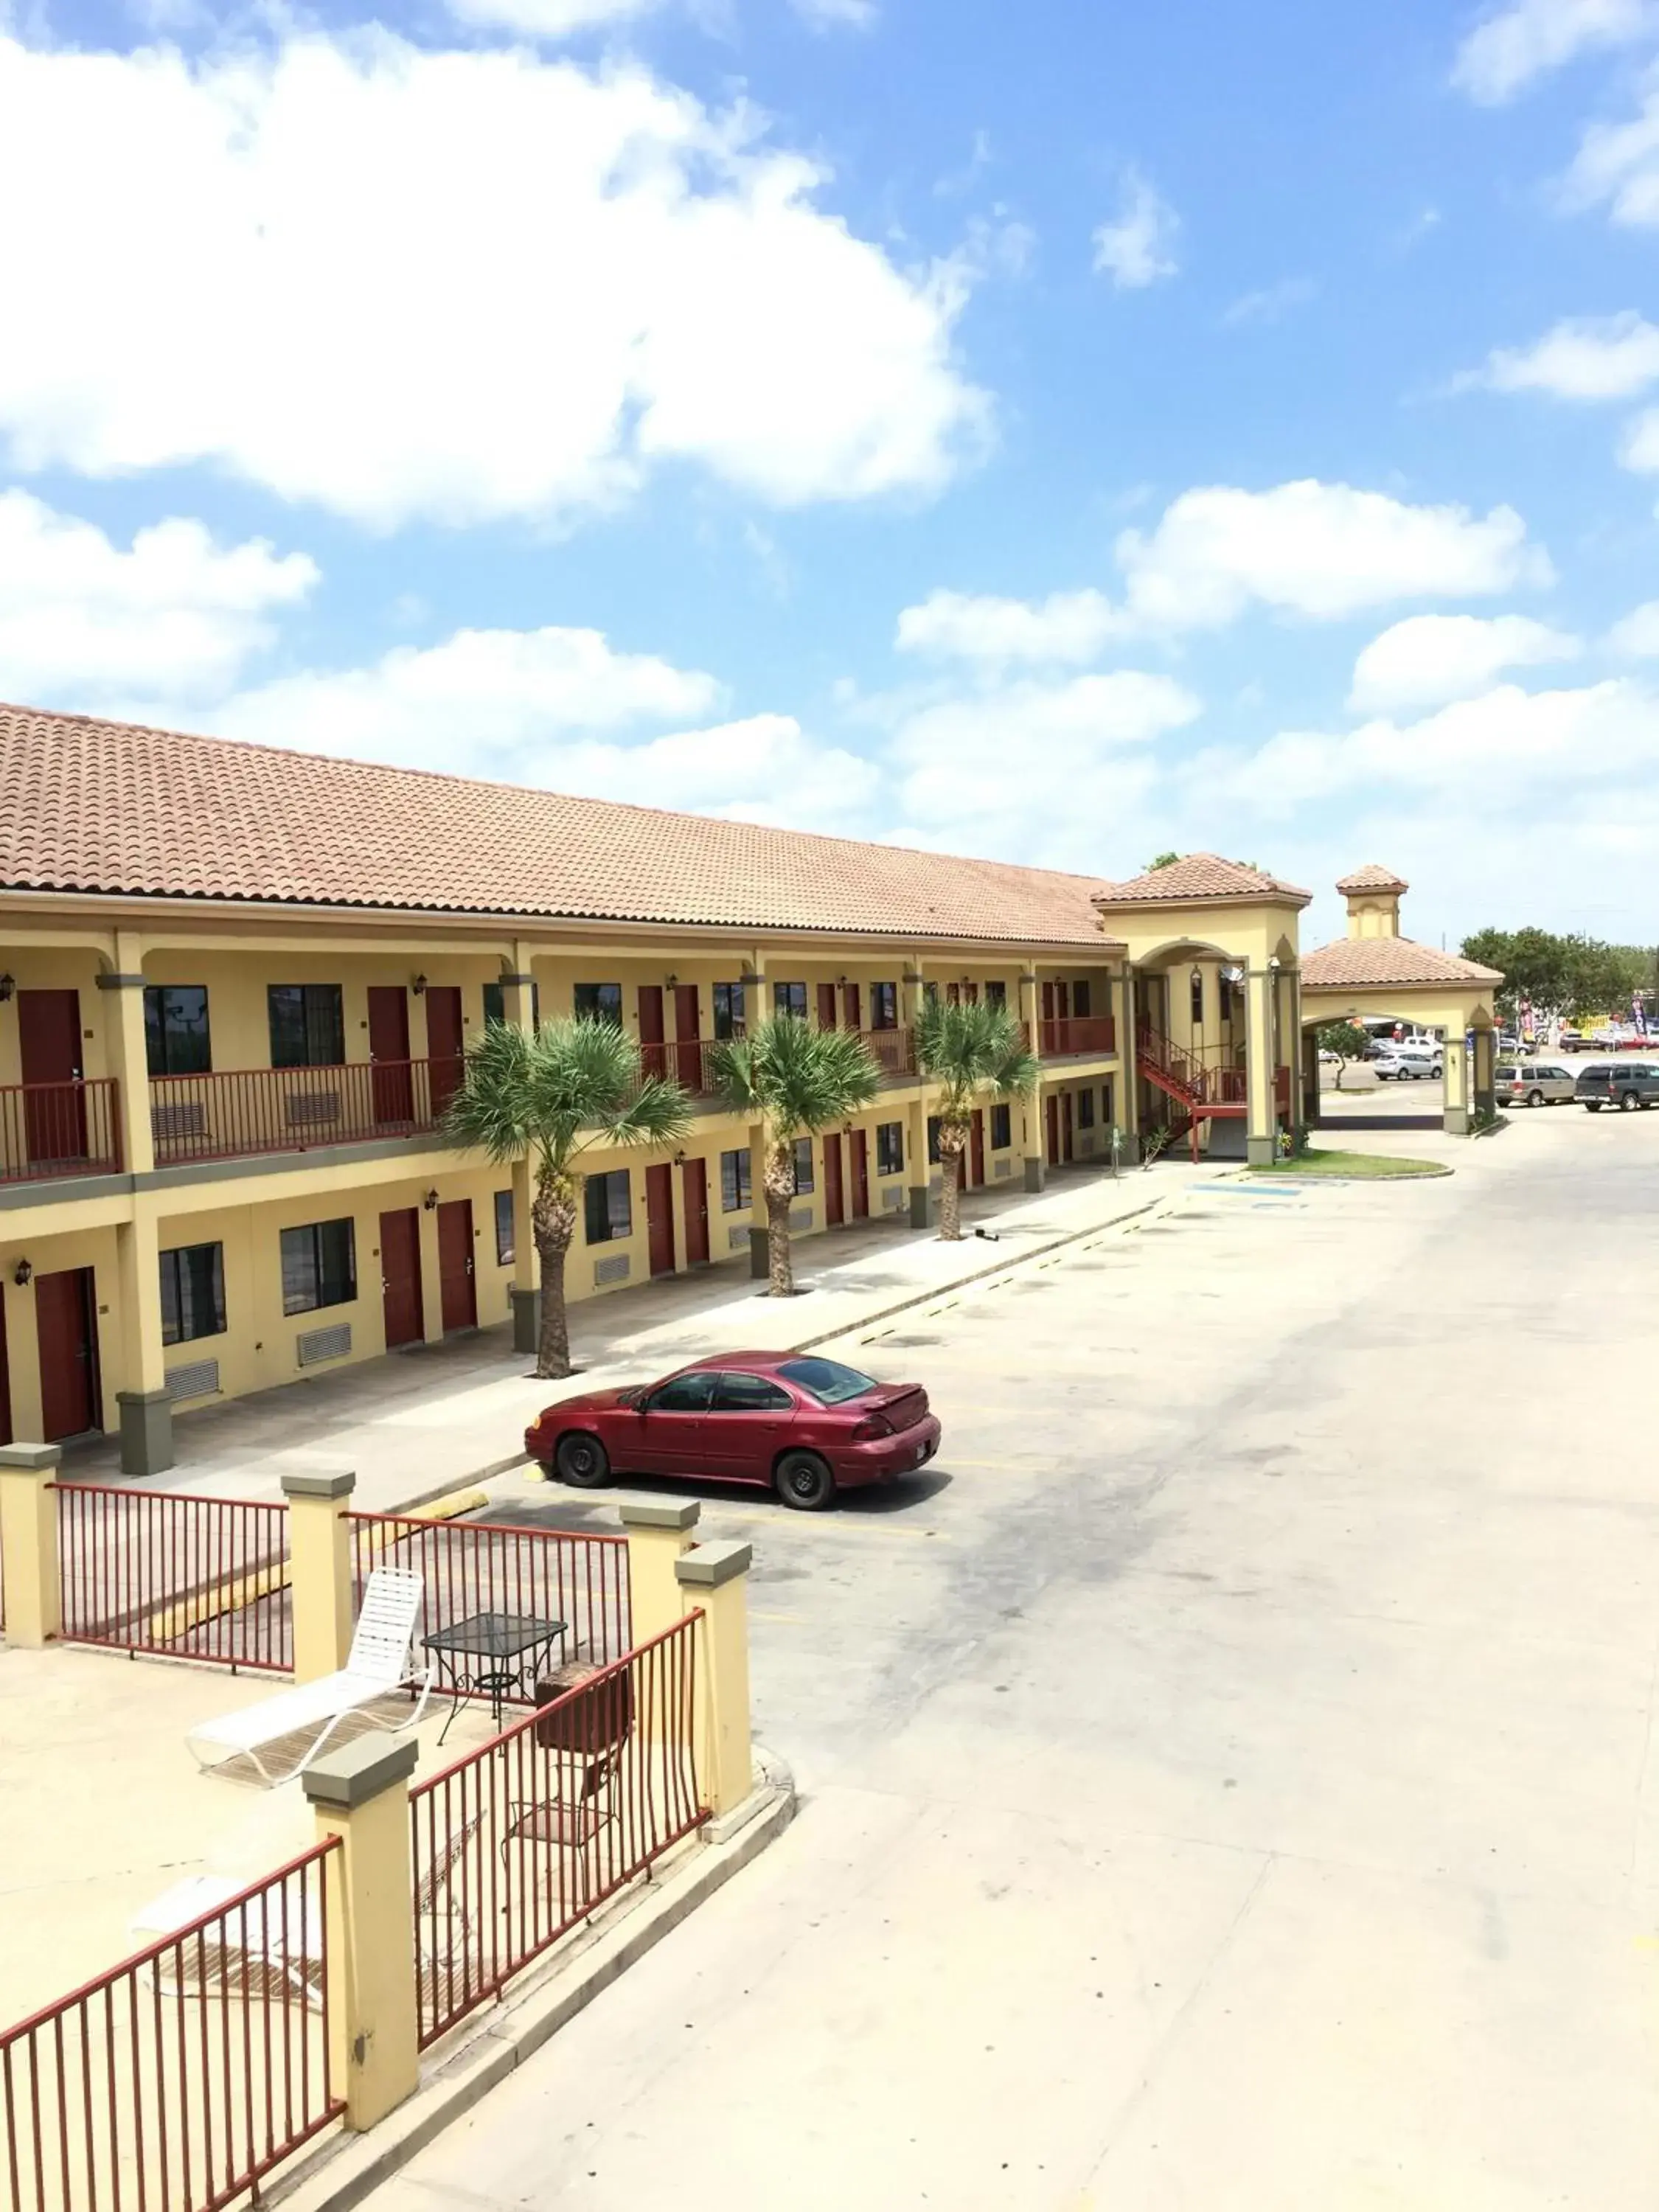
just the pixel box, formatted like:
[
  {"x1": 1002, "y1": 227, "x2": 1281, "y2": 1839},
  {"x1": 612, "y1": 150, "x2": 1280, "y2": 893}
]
[{"x1": 1117, "y1": 480, "x2": 1551, "y2": 630}]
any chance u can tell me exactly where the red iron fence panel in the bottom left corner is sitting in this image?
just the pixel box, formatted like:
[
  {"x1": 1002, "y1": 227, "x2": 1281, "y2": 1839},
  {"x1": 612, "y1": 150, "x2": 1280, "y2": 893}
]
[{"x1": 0, "y1": 1840, "x2": 345, "y2": 2212}]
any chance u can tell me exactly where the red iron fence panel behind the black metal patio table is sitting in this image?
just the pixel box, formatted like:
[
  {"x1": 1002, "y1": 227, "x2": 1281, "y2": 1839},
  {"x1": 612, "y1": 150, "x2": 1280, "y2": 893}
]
[{"x1": 347, "y1": 1513, "x2": 633, "y2": 1703}]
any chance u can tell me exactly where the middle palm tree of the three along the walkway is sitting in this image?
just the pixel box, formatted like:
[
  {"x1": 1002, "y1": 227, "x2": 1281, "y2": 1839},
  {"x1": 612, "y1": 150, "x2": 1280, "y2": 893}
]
[{"x1": 708, "y1": 1013, "x2": 880, "y2": 1298}]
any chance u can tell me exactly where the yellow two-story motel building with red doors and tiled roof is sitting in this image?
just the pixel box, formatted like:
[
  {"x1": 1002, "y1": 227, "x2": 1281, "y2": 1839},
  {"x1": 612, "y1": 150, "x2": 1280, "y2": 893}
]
[{"x1": 0, "y1": 708, "x2": 1336, "y2": 1475}]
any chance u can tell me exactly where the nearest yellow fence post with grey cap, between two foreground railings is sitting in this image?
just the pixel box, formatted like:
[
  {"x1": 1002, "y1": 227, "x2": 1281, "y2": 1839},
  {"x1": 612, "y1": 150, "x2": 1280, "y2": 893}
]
[{"x1": 301, "y1": 1732, "x2": 420, "y2": 2128}]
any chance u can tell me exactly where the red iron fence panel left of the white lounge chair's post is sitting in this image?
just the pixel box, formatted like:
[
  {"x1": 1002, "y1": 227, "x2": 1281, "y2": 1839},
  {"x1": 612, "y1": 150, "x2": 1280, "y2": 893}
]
[{"x1": 53, "y1": 1482, "x2": 294, "y2": 1672}]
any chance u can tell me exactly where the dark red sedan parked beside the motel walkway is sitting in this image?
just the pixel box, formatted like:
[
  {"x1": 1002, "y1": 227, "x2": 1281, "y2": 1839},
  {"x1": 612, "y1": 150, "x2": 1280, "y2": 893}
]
[{"x1": 524, "y1": 1352, "x2": 940, "y2": 1513}]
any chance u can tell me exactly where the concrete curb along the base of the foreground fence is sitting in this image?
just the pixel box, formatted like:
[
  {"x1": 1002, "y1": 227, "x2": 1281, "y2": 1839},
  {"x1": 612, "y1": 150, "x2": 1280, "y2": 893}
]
[{"x1": 263, "y1": 1756, "x2": 796, "y2": 2212}]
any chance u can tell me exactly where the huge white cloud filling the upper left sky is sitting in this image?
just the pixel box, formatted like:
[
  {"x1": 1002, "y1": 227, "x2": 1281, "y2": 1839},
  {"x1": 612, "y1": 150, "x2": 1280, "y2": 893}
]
[{"x1": 0, "y1": 34, "x2": 989, "y2": 526}]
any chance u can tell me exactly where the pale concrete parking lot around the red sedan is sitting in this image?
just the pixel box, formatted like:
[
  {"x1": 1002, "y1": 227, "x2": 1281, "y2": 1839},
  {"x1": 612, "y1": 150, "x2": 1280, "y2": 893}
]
[{"x1": 376, "y1": 1113, "x2": 1659, "y2": 2212}]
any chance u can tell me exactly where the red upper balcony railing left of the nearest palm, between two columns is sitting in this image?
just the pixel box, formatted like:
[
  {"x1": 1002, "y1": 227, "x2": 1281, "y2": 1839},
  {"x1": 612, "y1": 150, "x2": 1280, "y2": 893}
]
[{"x1": 150, "y1": 1060, "x2": 462, "y2": 1168}]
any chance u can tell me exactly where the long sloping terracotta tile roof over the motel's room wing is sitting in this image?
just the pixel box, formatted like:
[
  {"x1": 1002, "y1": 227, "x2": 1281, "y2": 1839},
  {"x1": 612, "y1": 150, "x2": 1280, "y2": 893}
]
[{"x1": 0, "y1": 706, "x2": 1115, "y2": 951}]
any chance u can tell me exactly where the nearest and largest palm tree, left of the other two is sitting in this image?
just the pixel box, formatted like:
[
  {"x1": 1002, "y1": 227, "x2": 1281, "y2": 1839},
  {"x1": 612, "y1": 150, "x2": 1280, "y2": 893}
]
[{"x1": 442, "y1": 1022, "x2": 692, "y2": 1376}]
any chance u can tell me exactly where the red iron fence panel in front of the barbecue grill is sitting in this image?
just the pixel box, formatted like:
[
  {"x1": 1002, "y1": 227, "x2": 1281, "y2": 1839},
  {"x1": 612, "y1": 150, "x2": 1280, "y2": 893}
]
[{"x1": 409, "y1": 1615, "x2": 706, "y2": 2048}]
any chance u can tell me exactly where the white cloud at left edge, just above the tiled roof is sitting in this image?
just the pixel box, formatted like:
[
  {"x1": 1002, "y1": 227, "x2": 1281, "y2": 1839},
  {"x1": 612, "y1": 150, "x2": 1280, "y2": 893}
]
[{"x1": 0, "y1": 491, "x2": 316, "y2": 706}]
